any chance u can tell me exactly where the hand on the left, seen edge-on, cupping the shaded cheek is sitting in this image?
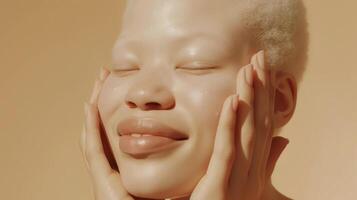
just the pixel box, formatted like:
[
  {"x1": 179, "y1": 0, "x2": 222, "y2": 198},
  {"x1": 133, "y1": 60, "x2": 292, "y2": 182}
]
[{"x1": 80, "y1": 69, "x2": 139, "y2": 200}]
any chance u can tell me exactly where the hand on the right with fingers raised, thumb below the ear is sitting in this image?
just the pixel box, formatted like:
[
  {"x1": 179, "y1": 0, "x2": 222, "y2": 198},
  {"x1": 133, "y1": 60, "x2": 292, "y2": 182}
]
[{"x1": 190, "y1": 51, "x2": 288, "y2": 200}]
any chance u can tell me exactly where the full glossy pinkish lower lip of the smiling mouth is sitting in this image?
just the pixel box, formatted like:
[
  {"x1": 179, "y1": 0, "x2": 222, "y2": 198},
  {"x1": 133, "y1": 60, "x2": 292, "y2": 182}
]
[{"x1": 119, "y1": 135, "x2": 184, "y2": 155}]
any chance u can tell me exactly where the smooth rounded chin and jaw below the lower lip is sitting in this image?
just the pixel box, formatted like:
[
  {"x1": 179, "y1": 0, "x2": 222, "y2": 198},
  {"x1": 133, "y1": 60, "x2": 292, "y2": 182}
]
[{"x1": 117, "y1": 134, "x2": 211, "y2": 199}]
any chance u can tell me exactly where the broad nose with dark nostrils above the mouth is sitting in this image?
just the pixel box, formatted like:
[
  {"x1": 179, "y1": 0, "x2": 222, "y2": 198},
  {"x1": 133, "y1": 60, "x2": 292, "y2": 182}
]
[{"x1": 125, "y1": 72, "x2": 175, "y2": 110}]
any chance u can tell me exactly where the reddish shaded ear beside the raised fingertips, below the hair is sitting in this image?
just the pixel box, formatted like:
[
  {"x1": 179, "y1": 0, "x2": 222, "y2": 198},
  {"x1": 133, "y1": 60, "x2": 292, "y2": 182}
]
[{"x1": 273, "y1": 71, "x2": 297, "y2": 128}]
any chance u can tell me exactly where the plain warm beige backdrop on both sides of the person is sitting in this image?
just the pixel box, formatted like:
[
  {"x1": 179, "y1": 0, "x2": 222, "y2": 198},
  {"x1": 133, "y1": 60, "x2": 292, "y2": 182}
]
[{"x1": 0, "y1": 0, "x2": 357, "y2": 200}]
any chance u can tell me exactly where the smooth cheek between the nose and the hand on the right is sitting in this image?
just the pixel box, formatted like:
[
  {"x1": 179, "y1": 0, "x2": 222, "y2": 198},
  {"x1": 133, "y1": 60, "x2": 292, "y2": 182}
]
[{"x1": 176, "y1": 73, "x2": 235, "y2": 152}]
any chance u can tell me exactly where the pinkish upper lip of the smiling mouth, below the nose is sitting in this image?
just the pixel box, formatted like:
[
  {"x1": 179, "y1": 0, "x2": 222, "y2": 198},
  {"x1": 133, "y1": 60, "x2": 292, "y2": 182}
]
[{"x1": 117, "y1": 118, "x2": 188, "y2": 140}]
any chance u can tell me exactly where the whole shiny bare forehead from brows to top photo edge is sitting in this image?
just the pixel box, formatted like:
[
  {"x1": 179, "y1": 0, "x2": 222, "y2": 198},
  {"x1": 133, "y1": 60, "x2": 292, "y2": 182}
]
[{"x1": 113, "y1": 0, "x2": 248, "y2": 60}]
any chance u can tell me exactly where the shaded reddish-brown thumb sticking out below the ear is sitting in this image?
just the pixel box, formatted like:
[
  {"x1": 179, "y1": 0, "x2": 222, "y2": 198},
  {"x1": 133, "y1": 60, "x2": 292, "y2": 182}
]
[{"x1": 266, "y1": 136, "x2": 289, "y2": 179}]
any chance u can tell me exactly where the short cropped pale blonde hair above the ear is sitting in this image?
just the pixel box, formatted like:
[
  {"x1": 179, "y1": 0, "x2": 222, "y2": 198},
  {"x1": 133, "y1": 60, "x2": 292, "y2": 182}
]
[{"x1": 241, "y1": 0, "x2": 308, "y2": 82}]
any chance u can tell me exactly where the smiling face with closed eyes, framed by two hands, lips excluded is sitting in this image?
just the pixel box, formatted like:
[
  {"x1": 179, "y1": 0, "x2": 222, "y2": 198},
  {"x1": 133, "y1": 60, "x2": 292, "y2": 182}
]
[{"x1": 99, "y1": 0, "x2": 255, "y2": 198}]
